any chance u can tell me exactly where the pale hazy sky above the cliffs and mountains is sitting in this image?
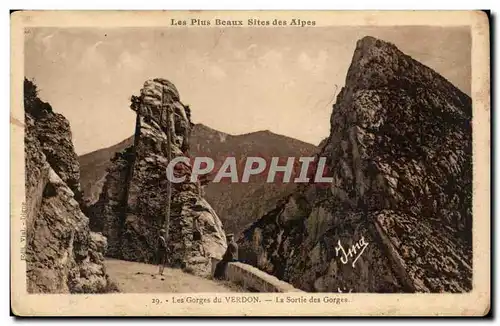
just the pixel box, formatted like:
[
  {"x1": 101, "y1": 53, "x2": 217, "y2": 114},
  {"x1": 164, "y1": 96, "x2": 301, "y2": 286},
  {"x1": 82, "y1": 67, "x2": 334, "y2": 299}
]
[{"x1": 25, "y1": 27, "x2": 471, "y2": 154}]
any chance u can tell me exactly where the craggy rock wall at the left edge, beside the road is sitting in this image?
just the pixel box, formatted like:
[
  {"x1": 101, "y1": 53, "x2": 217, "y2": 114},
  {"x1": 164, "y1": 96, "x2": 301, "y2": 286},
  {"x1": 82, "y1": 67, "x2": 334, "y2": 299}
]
[{"x1": 24, "y1": 80, "x2": 109, "y2": 293}]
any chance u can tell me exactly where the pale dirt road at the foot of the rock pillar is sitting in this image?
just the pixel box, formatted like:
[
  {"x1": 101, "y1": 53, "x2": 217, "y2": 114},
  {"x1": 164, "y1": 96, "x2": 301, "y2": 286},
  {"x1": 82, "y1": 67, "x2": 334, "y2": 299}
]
[{"x1": 105, "y1": 259, "x2": 241, "y2": 293}]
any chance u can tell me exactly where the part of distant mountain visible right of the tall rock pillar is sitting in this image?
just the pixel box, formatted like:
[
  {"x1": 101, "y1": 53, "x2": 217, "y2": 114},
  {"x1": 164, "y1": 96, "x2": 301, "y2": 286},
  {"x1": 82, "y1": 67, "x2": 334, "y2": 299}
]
[{"x1": 190, "y1": 124, "x2": 318, "y2": 233}]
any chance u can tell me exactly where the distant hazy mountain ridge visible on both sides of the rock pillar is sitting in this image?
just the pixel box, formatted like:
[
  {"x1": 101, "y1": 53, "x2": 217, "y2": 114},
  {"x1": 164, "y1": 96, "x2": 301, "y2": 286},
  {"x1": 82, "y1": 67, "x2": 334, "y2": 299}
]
[{"x1": 79, "y1": 124, "x2": 318, "y2": 232}]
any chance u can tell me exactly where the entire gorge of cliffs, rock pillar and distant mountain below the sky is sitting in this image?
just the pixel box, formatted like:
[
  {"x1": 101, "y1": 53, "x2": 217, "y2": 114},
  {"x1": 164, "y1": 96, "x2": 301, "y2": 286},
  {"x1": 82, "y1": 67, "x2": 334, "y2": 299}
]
[{"x1": 24, "y1": 37, "x2": 473, "y2": 293}]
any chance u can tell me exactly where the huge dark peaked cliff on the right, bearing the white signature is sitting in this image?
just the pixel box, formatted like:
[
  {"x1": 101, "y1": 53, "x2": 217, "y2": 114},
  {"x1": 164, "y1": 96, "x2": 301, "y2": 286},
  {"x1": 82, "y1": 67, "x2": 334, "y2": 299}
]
[{"x1": 238, "y1": 37, "x2": 472, "y2": 292}]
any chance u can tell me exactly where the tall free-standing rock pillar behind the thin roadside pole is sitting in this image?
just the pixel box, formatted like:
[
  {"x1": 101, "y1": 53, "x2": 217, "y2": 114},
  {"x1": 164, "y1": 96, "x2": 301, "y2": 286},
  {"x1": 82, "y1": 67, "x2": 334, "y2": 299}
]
[{"x1": 90, "y1": 78, "x2": 226, "y2": 275}]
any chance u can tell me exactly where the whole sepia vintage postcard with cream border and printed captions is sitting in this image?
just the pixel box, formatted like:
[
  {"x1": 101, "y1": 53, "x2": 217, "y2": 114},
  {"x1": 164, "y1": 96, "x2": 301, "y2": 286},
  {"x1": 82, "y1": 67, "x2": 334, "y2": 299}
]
[{"x1": 10, "y1": 11, "x2": 491, "y2": 316}]
